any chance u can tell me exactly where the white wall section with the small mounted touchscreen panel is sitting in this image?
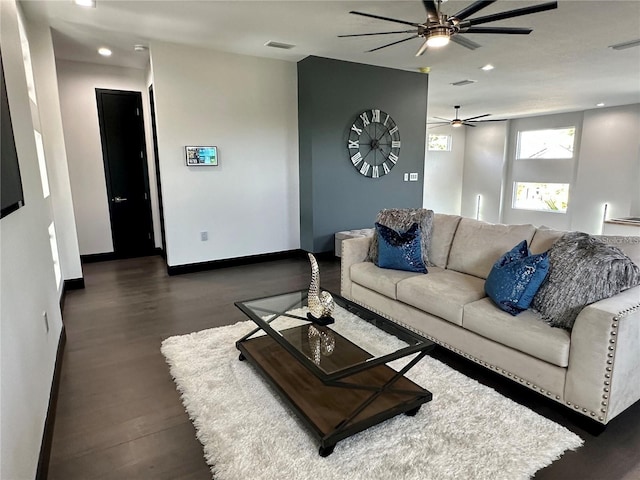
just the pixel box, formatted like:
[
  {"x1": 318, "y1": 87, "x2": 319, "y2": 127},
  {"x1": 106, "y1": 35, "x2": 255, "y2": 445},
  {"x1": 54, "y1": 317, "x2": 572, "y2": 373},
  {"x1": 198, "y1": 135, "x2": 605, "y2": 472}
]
[{"x1": 150, "y1": 42, "x2": 300, "y2": 266}]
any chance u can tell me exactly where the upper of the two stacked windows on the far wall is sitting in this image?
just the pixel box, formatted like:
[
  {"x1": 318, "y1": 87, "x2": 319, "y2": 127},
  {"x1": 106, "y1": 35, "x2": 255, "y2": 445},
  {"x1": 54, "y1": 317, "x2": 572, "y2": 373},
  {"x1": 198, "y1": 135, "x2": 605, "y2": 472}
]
[{"x1": 516, "y1": 127, "x2": 576, "y2": 160}]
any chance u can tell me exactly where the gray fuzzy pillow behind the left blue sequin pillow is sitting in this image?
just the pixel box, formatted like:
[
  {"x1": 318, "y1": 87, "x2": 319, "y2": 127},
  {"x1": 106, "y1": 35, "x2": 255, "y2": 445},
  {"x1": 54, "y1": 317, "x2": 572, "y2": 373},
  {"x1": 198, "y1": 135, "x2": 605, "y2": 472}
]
[{"x1": 367, "y1": 208, "x2": 433, "y2": 265}]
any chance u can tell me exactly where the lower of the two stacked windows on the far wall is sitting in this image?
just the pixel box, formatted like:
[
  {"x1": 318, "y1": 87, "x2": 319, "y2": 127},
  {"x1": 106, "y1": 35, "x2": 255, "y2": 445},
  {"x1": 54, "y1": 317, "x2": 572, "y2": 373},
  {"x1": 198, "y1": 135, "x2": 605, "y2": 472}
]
[{"x1": 513, "y1": 182, "x2": 569, "y2": 213}]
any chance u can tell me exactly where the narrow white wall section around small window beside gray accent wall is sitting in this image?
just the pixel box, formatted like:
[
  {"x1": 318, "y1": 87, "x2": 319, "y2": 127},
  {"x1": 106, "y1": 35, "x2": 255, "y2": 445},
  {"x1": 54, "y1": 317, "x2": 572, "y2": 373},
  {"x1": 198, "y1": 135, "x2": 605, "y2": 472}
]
[{"x1": 422, "y1": 126, "x2": 467, "y2": 215}]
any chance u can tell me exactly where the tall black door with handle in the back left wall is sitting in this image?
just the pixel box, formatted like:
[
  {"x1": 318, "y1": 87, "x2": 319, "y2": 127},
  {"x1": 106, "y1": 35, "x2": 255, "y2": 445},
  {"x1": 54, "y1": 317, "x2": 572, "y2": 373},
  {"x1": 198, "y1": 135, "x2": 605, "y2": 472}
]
[{"x1": 96, "y1": 89, "x2": 153, "y2": 257}]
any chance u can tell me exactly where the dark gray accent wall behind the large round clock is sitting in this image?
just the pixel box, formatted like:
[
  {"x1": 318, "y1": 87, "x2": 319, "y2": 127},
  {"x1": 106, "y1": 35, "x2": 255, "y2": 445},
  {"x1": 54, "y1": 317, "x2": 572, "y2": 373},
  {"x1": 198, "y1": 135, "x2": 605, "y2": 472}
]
[{"x1": 298, "y1": 57, "x2": 428, "y2": 253}]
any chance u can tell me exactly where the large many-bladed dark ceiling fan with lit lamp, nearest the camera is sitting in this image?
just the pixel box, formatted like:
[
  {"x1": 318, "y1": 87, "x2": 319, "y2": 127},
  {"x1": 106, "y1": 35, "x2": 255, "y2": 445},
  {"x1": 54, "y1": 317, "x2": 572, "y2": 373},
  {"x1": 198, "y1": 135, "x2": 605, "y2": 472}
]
[{"x1": 338, "y1": 0, "x2": 558, "y2": 57}]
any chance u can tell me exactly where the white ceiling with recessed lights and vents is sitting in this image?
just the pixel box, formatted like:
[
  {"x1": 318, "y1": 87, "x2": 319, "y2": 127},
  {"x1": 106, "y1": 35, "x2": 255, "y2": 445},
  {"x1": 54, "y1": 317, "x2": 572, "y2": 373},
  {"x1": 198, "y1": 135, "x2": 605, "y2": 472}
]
[{"x1": 20, "y1": 0, "x2": 640, "y2": 118}]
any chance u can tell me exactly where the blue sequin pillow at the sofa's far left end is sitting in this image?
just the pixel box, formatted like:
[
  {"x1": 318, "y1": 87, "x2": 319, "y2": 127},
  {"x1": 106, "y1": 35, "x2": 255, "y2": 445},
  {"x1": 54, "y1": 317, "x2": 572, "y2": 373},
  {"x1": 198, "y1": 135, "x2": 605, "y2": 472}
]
[{"x1": 376, "y1": 223, "x2": 427, "y2": 273}]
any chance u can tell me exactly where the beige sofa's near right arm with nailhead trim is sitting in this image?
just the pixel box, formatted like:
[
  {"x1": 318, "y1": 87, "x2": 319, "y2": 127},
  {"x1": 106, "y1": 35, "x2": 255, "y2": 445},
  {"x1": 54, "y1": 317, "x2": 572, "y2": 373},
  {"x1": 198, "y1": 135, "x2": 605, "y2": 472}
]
[{"x1": 564, "y1": 287, "x2": 640, "y2": 423}]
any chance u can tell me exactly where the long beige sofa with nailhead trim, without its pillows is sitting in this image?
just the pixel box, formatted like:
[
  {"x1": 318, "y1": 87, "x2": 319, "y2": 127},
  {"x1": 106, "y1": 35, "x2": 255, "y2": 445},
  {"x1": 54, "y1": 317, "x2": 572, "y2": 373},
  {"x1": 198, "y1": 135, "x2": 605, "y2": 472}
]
[{"x1": 341, "y1": 214, "x2": 640, "y2": 424}]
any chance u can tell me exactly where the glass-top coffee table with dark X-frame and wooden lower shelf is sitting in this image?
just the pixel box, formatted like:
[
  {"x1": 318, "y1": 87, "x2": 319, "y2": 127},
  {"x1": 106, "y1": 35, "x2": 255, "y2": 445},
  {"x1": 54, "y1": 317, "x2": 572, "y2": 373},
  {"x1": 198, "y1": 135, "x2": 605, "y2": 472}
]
[{"x1": 235, "y1": 290, "x2": 434, "y2": 457}]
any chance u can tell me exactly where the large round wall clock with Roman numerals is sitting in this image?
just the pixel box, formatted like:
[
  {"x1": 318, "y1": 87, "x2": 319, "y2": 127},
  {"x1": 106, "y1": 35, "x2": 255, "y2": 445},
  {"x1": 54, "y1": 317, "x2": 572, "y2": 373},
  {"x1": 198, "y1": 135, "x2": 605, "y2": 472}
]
[{"x1": 347, "y1": 109, "x2": 400, "y2": 178}]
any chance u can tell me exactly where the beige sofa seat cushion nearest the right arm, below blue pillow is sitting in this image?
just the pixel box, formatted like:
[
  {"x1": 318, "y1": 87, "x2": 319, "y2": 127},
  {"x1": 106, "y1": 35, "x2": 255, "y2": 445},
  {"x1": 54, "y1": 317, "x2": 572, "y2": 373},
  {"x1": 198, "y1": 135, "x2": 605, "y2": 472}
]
[{"x1": 462, "y1": 298, "x2": 571, "y2": 367}]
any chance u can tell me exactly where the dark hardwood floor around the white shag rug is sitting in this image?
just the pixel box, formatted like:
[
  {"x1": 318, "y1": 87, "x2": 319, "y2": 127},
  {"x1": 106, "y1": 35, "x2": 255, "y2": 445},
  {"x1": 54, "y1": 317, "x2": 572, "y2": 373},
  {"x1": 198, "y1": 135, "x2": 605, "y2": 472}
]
[{"x1": 49, "y1": 257, "x2": 640, "y2": 480}]
